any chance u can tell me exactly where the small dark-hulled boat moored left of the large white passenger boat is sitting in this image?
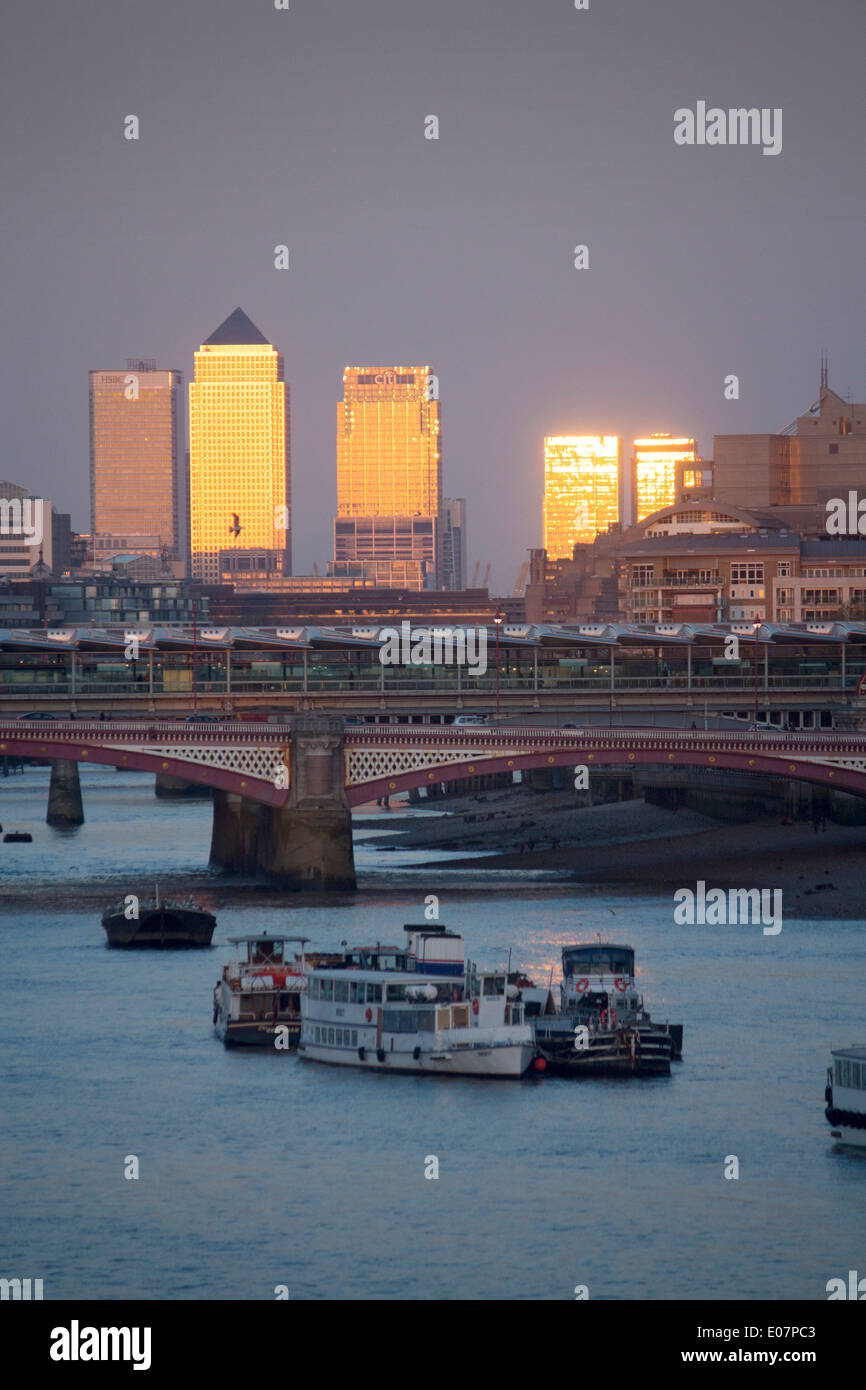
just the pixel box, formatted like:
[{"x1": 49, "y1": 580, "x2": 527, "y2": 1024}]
[{"x1": 214, "y1": 931, "x2": 315, "y2": 1051}]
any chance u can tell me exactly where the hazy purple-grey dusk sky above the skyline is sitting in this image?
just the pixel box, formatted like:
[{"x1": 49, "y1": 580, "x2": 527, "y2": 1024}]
[{"x1": 0, "y1": 0, "x2": 866, "y2": 592}]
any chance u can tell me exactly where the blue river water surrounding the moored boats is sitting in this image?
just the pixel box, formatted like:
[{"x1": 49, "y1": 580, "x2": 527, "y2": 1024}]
[{"x1": 0, "y1": 769, "x2": 866, "y2": 1300}]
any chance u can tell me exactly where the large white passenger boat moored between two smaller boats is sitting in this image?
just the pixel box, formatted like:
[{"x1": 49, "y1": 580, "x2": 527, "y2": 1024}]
[{"x1": 297, "y1": 926, "x2": 535, "y2": 1077}]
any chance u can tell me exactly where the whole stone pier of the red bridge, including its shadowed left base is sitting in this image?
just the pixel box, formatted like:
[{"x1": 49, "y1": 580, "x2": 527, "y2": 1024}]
[{"x1": 210, "y1": 714, "x2": 356, "y2": 892}]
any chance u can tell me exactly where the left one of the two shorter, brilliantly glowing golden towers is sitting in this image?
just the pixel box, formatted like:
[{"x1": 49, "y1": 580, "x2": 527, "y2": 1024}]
[{"x1": 544, "y1": 435, "x2": 620, "y2": 560}]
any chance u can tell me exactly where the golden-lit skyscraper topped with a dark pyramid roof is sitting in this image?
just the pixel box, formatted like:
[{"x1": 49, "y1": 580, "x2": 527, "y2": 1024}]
[{"x1": 189, "y1": 309, "x2": 292, "y2": 584}]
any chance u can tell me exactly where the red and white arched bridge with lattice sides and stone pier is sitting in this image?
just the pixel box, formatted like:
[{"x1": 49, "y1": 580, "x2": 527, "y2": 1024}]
[{"x1": 0, "y1": 714, "x2": 866, "y2": 888}]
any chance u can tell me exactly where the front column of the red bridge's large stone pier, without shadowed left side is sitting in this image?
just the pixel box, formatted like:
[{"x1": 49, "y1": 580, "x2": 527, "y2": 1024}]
[{"x1": 259, "y1": 714, "x2": 356, "y2": 892}]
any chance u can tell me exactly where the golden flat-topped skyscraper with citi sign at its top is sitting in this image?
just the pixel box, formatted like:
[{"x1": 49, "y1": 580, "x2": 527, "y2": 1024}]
[{"x1": 334, "y1": 367, "x2": 442, "y2": 588}]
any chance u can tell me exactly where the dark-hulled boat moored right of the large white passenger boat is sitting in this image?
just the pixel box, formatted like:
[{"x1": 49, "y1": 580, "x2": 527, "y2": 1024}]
[{"x1": 534, "y1": 942, "x2": 683, "y2": 1076}]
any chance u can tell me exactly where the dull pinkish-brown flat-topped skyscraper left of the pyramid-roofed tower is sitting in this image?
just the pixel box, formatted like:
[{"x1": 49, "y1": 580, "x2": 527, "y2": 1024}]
[{"x1": 90, "y1": 357, "x2": 183, "y2": 559}]
